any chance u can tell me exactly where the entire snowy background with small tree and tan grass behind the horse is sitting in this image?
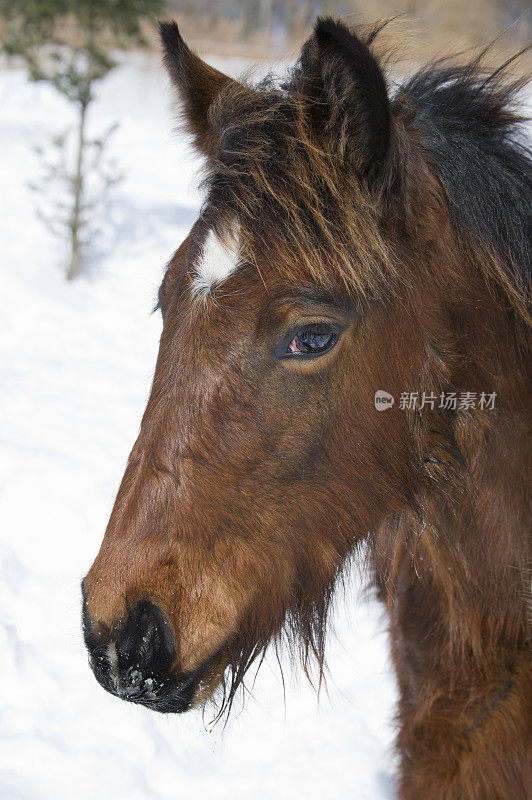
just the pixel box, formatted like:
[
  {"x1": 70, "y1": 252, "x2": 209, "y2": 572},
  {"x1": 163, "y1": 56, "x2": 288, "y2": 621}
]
[{"x1": 0, "y1": 0, "x2": 530, "y2": 800}]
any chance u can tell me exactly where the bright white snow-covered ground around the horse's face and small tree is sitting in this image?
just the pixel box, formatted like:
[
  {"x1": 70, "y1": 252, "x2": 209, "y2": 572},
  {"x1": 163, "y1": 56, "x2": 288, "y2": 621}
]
[{"x1": 0, "y1": 57, "x2": 396, "y2": 800}]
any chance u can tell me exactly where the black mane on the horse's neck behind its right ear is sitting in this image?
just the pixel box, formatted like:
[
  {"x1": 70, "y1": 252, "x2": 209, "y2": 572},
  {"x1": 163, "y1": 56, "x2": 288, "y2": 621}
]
[{"x1": 402, "y1": 58, "x2": 532, "y2": 304}]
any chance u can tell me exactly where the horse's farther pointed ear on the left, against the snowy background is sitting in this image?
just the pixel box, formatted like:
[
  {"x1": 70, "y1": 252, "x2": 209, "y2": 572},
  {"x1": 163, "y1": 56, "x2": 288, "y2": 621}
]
[{"x1": 159, "y1": 22, "x2": 234, "y2": 156}]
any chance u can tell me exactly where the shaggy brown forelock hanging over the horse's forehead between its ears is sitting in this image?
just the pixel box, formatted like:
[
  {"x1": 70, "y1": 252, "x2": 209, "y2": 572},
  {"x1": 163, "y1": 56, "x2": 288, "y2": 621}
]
[{"x1": 200, "y1": 79, "x2": 394, "y2": 304}]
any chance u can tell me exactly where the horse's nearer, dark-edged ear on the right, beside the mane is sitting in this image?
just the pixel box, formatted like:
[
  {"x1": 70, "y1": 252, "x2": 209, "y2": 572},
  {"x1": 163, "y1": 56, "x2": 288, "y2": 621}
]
[{"x1": 300, "y1": 18, "x2": 392, "y2": 177}]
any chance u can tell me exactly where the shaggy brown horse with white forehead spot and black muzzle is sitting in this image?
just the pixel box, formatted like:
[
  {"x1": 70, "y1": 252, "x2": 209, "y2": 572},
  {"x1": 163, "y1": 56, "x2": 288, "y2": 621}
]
[{"x1": 83, "y1": 19, "x2": 532, "y2": 800}]
